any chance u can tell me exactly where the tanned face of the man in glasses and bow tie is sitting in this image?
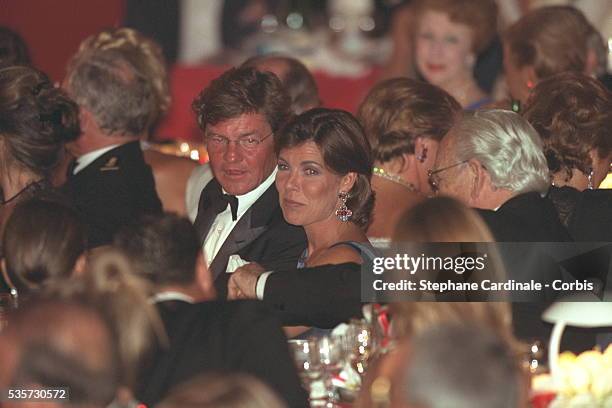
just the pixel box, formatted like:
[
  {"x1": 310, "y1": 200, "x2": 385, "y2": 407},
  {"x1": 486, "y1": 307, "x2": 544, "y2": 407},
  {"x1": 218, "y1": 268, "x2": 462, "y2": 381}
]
[{"x1": 204, "y1": 113, "x2": 276, "y2": 195}]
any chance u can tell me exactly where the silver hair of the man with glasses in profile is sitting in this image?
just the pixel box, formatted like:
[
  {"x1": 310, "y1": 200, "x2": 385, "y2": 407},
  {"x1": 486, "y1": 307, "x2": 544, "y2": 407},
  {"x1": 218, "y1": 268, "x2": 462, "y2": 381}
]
[{"x1": 454, "y1": 109, "x2": 550, "y2": 194}]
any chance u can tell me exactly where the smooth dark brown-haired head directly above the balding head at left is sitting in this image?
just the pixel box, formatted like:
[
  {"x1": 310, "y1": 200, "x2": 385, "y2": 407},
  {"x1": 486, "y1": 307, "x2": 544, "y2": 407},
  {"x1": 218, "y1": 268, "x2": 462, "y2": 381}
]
[{"x1": 2, "y1": 199, "x2": 86, "y2": 298}]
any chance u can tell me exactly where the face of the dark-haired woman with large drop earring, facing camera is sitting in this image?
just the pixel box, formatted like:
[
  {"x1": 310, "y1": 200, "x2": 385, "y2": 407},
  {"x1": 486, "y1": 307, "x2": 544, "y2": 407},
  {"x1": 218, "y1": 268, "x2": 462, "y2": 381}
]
[{"x1": 276, "y1": 141, "x2": 352, "y2": 226}]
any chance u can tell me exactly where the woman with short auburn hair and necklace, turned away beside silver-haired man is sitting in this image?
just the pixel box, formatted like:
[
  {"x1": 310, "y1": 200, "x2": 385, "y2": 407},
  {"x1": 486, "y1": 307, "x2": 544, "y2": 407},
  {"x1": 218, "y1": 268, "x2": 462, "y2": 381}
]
[{"x1": 357, "y1": 78, "x2": 461, "y2": 241}]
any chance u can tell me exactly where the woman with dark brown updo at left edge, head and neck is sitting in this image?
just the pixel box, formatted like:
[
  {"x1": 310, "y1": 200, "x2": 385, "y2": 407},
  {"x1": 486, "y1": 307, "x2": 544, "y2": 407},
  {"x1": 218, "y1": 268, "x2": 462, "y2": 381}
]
[{"x1": 0, "y1": 66, "x2": 80, "y2": 247}]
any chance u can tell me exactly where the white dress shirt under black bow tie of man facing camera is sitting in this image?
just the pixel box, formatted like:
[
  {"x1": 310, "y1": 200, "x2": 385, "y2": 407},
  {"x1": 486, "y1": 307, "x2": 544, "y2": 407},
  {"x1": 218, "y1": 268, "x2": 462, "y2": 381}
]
[{"x1": 203, "y1": 168, "x2": 276, "y2": 266}]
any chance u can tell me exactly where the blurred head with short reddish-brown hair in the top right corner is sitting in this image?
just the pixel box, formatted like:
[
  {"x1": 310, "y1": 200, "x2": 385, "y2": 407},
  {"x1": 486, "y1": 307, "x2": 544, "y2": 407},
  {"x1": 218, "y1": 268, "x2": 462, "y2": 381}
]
[{"x1": 503, "y1": 6, "x2": 603, "y2": 108}]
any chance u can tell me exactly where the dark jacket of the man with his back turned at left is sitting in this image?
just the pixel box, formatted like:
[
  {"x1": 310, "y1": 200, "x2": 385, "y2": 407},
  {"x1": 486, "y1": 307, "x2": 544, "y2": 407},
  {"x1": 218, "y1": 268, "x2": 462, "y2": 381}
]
[{"x1": 64, "y1": 141, "x2": 162, "y2": 247}]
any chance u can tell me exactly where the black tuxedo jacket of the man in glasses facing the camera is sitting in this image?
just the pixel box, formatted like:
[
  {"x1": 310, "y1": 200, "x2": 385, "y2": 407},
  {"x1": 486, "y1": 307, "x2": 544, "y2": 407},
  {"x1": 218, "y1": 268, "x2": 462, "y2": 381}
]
[{"x1": 194, "y1": 179, "x2": 306, "y2": 299}]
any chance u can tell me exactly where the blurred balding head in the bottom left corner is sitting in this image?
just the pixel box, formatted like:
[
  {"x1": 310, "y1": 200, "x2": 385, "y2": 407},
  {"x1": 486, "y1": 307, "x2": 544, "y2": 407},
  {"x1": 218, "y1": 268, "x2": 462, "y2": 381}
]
[{"x1": 0, "y1": 300, "x2": 119, "y2": 407}]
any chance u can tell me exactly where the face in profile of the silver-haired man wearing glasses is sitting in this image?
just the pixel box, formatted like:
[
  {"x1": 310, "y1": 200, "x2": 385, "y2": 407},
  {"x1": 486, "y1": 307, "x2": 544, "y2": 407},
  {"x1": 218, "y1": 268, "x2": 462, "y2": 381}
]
[{"x1": 430, "y1": 130, "x2": 470, "y2": 205}]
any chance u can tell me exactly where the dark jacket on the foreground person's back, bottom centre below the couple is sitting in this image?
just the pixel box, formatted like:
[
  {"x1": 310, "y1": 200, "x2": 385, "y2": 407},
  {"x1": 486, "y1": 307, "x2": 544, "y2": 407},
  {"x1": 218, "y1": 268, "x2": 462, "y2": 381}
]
[{"x1": 136, "y1": 301, "x2": 307, "y2": 407}]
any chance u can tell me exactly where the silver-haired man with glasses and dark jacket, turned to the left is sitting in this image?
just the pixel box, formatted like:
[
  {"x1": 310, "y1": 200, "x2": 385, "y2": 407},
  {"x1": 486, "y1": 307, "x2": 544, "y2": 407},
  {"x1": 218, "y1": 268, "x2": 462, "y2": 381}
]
[{"x1": 429, "y1": 110, "x2": 571, "y2": 242}]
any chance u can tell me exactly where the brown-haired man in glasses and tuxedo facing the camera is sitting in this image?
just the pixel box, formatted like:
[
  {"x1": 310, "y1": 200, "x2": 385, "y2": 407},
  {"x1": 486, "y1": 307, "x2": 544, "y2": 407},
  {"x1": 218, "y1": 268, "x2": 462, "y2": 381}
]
[{"x1": 193, "y1": 68, "x2": 306, "y2": 299}]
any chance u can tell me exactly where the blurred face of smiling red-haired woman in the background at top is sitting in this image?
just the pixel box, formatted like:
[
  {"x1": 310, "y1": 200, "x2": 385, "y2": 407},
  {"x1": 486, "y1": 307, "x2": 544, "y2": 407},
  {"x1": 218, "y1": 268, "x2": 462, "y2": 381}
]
[{"x1": 416, "y1": 10, "x2": 475, "y2": 87}]
